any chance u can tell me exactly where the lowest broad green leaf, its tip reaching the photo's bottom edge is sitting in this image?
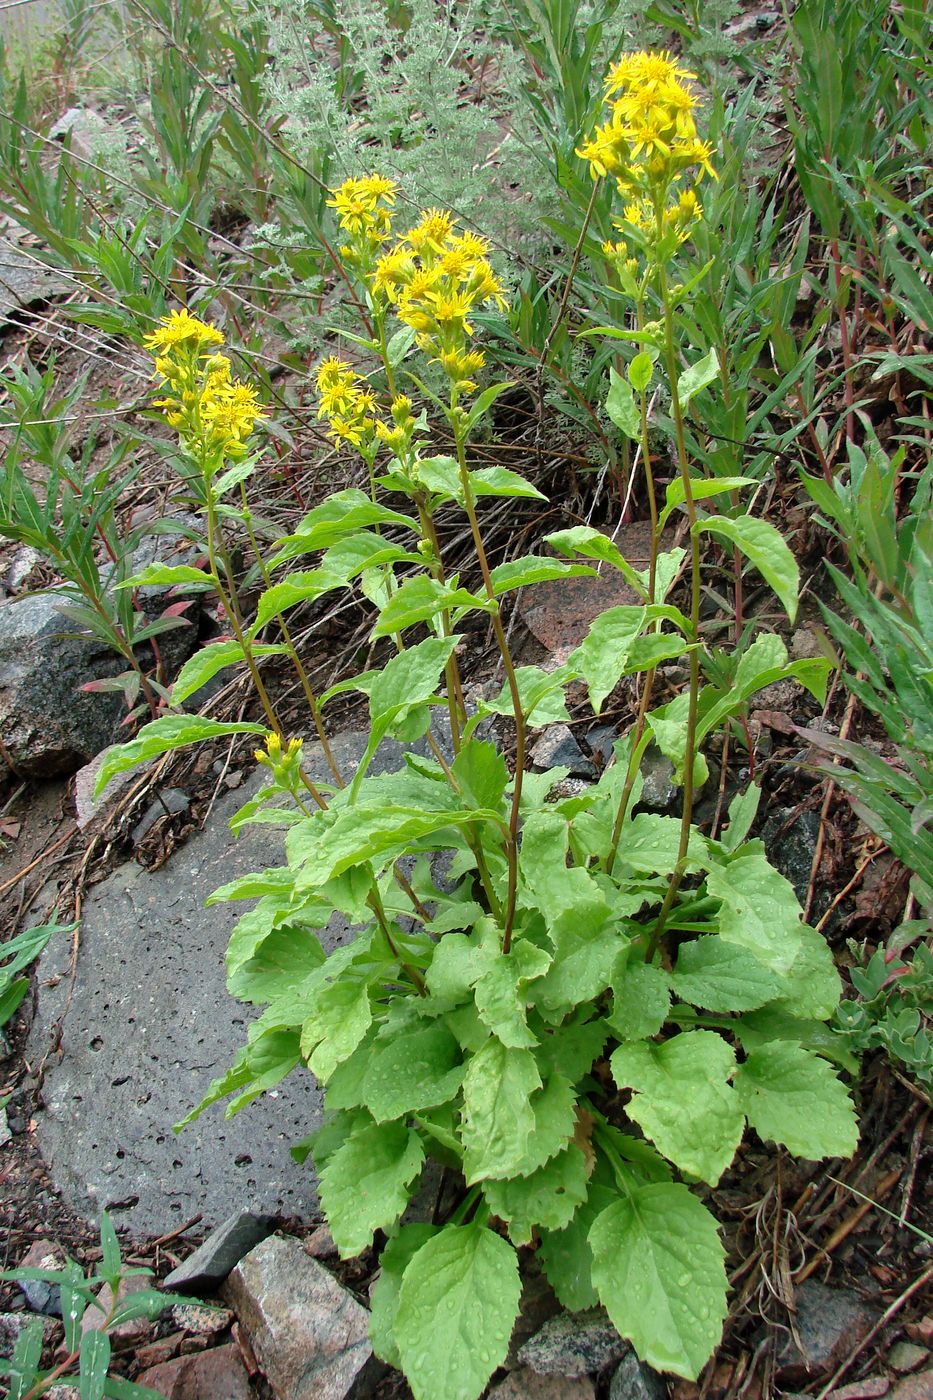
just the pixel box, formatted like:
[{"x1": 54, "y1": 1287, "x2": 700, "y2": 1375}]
[{"x1": 395, "y1": 1224, "x2": 521, "y2": 1400}]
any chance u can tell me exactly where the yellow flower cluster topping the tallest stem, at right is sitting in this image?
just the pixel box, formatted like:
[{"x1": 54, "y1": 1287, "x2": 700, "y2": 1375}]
[{"x1": 577, "y1": 52, "x2": 716, "y2": 269}]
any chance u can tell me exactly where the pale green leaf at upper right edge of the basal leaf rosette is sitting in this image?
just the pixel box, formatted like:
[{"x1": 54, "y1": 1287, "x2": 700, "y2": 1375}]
[{"x1": 706, "y1": 853, "x2": 803, "y2": 973}]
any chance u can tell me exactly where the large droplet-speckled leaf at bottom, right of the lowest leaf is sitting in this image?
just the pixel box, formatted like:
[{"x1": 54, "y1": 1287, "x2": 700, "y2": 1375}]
[{"x1": 590, "y1": 1183, "x2": 727, "y2": 1380}]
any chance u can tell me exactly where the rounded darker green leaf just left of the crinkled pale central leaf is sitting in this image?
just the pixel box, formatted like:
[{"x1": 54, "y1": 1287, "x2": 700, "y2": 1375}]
[{"x1": 360, "y1": 1023, "x2": 464, "y2": 1123}]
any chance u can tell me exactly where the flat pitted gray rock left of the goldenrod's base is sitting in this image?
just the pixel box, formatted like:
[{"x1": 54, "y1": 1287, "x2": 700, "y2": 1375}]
[{"x1": 29, "y1": 734, "x2": 402, "y2": 1235}]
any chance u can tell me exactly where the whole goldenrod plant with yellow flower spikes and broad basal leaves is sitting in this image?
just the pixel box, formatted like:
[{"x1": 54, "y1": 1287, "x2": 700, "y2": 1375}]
[{"x1": 99, "y1": 53, "x2": 857, "y2": 1400}]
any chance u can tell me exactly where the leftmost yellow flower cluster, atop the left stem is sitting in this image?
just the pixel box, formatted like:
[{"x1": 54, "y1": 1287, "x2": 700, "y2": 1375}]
[{"x1": 144, "y1": 309, "x2": 262, "y2": 461}]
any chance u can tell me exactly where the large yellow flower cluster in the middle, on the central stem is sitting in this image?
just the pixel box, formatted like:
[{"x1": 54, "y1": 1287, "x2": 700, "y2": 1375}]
[{"x1": 373, "y1": 209, "x2": 506, "y2": 392}]
